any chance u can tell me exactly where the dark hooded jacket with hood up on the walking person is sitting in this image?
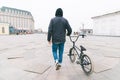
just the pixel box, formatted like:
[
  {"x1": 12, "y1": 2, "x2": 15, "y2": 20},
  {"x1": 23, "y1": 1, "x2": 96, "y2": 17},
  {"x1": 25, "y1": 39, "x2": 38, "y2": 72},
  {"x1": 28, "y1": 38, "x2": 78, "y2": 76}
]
[{"x1": 47, "y1": 8, "x2": 72, "y2": 43}]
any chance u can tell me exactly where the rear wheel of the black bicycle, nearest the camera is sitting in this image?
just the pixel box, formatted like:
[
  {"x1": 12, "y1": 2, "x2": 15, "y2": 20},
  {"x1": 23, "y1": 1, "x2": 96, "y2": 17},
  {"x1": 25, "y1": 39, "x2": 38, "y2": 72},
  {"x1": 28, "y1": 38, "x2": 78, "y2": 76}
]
[{"x1": 81, "y1": 54, "x2": 93, "y2": 75}]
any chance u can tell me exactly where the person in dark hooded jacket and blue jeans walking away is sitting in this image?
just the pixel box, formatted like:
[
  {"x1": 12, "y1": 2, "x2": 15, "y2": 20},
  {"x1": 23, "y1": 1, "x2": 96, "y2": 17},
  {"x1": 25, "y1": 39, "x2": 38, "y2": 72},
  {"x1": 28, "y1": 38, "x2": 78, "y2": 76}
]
[{"x1": 47, "y1": 8, "x2": 72, "y2": 70}]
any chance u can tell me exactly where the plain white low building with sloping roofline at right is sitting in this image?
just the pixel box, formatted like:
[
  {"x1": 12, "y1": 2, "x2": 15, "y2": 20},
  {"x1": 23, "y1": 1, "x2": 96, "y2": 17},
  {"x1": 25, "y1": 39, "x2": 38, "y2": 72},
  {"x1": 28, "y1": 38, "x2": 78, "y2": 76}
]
[{"x1": 92, "y1": 11, "x2": 120, "y2": 36}]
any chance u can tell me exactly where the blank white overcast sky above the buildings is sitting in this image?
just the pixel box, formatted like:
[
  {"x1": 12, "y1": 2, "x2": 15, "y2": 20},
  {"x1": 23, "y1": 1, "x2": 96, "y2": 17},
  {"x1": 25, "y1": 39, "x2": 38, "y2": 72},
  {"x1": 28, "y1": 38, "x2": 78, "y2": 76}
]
[{"x1": 0, "y1": 0, "x2": 120, "y2": 31}]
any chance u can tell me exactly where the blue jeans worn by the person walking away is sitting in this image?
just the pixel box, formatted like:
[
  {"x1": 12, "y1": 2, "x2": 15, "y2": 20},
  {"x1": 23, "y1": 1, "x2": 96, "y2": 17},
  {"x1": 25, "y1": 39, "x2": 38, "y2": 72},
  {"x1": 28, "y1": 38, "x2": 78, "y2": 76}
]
[{"x1": 52, "y1": 42, "x2": 64, "y2": 63}]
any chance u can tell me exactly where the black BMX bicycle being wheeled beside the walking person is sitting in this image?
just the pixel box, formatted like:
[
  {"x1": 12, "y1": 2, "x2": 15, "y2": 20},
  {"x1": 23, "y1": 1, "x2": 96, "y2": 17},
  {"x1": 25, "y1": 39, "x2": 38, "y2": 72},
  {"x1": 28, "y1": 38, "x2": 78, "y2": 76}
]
[{"x1": 68, "y1": 35, "x2": 93, "y2": 75}]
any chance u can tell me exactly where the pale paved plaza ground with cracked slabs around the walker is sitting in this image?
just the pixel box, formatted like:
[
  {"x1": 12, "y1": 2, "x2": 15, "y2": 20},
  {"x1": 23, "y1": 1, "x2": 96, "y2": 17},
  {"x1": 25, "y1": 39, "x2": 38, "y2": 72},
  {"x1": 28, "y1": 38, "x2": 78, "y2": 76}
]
[{"x1": 0, "y1": 34, "x2": 120, "y2": 80}]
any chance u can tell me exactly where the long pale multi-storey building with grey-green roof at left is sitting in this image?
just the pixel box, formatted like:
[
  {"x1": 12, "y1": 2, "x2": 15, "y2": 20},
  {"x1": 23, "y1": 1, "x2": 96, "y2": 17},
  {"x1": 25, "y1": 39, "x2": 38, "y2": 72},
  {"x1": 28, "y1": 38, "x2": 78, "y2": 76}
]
[{"x1": 0, "y1": 7, "x2": 34, "y2": 33}]
